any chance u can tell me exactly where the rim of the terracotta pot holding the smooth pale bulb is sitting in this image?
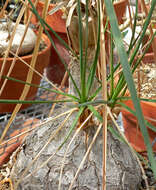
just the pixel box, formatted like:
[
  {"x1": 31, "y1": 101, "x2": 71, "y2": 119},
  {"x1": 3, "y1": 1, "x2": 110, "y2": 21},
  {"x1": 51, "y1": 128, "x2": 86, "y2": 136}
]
[{"x1": 0, "y1": 34, "x2": 51, "y2": 61}]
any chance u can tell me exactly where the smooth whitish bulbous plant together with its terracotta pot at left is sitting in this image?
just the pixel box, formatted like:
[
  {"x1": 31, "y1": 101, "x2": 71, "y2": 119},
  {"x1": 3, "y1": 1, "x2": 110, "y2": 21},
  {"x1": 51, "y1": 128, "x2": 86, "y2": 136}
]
[{"x1": 0, "y1": 21, "x2": 51, "y2": 113}]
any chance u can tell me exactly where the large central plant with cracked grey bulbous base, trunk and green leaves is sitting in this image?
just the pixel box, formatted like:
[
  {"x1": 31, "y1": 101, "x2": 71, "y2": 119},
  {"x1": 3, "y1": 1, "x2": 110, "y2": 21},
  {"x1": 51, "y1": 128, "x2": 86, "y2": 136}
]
[{"x1": 0, "y1": 0, "x2": 156, "y2": 189}]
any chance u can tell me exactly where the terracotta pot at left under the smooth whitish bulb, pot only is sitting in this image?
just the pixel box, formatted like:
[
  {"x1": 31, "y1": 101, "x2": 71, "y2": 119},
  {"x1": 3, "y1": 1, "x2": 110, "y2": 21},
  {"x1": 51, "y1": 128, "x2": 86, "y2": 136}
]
[{"x1": 0, "y1": 34, "x2": 51, "y2": 113}]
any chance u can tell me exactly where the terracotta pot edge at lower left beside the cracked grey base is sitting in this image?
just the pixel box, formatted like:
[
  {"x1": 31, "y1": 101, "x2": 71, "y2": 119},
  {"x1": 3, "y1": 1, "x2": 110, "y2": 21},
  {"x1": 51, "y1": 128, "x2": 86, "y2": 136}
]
[{"x1": 0, "y1": 118, "x2": 39, "y2": 166}]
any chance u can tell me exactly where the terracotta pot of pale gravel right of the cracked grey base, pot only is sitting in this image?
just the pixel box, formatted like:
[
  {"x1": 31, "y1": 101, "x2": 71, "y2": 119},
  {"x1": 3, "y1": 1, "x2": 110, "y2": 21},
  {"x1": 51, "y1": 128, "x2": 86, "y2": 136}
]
[{"x1": 122, "y1": 53, "x2": 156, "y2": 152}]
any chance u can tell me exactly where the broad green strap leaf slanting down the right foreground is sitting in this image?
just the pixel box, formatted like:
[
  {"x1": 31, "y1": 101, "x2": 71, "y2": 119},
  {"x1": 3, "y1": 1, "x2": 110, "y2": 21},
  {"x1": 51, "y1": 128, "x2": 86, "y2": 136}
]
[{"x1": 105, "y1": 0, "x2": 156, "y2": 178}]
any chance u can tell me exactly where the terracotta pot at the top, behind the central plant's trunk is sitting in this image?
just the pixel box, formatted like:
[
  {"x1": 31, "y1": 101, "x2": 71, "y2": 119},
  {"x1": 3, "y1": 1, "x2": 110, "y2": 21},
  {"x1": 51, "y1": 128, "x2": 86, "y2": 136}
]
[{"x1": 31, "y1": 0, "x2": 128, "y2": 86}]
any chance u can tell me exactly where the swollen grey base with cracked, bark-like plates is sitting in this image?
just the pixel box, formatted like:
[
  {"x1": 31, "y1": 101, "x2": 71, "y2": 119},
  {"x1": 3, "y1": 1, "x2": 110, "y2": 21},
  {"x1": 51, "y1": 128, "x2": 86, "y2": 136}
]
[{"x1": 11, "y1": 107, "x2": 141, "y2": 190}]
